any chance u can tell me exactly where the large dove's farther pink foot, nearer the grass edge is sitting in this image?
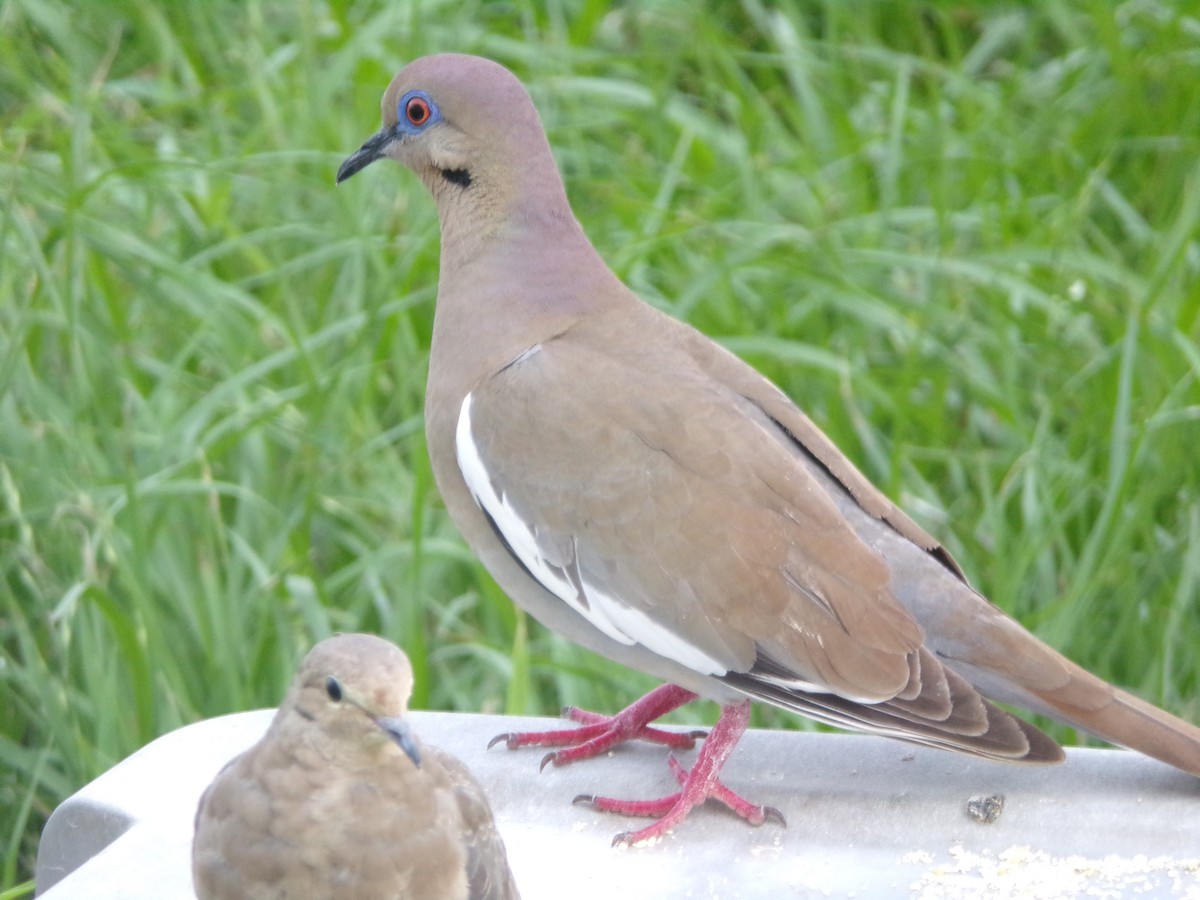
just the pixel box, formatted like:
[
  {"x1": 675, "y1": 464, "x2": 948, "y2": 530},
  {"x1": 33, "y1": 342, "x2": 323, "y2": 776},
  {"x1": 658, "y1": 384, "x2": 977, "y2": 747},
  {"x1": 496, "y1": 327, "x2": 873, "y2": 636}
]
[{"x1": 487, "y1": 684, "x2": 706, "y2": 768}]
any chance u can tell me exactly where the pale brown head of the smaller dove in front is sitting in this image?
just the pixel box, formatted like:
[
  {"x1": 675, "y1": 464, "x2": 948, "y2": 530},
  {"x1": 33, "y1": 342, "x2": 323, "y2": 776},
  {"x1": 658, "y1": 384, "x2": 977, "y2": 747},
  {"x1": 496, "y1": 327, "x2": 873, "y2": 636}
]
[{"x1": 280, "y1": 635, "x2": 421, "y2": 767}]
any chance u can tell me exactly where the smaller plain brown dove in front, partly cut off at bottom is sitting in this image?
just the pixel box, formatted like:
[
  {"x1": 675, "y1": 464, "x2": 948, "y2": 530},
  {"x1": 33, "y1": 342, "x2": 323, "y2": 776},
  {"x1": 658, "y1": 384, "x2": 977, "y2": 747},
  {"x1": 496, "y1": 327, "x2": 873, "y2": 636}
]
[{"x1": 192, "y1": 635, "x2": 518, "y2": 900}]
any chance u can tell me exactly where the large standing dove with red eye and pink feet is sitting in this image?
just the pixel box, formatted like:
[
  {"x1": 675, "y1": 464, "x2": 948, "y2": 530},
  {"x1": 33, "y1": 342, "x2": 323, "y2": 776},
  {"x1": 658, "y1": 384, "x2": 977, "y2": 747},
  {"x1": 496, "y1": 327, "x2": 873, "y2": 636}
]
[{"x1": 337, "y1": 55, "x2": 1200, "y2": 842}]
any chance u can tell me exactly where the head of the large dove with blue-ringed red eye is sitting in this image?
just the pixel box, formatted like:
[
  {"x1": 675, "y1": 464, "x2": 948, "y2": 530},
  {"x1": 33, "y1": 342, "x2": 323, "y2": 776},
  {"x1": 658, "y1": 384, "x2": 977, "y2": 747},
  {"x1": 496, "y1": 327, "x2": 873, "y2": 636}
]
[{"x1": 337, "y1": 54, "x2": 571, "y2": 250}]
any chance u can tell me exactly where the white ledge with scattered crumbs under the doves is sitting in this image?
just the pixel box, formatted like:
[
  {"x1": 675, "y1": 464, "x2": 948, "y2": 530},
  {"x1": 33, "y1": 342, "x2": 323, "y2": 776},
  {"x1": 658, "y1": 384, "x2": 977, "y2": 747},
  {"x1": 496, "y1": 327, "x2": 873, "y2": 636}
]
[{"x1": 37, "y1": 710, "x2": 1200, "y2": 900}]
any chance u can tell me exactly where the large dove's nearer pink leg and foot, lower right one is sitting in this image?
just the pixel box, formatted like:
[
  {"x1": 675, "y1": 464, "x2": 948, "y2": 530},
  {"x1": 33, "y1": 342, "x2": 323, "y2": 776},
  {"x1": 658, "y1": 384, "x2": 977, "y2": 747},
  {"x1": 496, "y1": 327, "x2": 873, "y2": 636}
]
[{"x1": 575, "y1": 701, "x2": 787, "y2": 847}]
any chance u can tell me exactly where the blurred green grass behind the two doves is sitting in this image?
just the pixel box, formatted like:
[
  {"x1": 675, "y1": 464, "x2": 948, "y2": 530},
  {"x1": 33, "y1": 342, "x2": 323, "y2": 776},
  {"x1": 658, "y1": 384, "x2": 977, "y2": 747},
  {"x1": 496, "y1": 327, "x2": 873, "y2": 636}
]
[{"x1": 0, "y1": 0, "x2": 1200, "y2": 896}]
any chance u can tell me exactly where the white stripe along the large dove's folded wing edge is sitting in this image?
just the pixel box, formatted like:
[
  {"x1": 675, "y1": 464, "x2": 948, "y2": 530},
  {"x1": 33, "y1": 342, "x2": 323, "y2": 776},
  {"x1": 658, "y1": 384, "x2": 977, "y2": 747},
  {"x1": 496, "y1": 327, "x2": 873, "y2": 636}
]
[{"x1": 455, "y1": 394, "x2": 728, "y2": 676}]
